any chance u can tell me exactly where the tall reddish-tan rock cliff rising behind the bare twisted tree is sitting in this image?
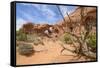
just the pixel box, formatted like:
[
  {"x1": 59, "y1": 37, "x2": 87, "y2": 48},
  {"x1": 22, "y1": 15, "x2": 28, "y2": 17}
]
[{"x1": 57, "y1": 7, "x2": 97, "y2": 33}]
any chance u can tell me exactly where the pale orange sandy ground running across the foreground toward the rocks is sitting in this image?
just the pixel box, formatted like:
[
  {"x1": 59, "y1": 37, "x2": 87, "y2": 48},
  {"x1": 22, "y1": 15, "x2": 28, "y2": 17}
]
[{"x1": 16, "y1": 39, "x2": 85, "y2": 65}]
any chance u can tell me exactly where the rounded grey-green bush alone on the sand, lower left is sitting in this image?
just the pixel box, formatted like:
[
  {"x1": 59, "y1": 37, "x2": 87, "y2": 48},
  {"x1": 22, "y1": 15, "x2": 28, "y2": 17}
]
[{"x1": 18, "y1": 44, "x2": 34, "y2": 56}]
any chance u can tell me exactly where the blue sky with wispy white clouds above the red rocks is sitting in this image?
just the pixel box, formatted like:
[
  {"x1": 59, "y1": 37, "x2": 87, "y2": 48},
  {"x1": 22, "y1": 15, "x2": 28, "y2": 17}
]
[{"x1": 16, "y1": 3, "x2": 76, "y2": 29}]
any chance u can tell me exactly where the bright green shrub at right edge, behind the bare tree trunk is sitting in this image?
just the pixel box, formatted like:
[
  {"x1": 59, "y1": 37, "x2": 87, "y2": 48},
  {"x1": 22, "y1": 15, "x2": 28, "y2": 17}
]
[{"x1": 87, "y1": 33, "x2": 96, "y2": 49}]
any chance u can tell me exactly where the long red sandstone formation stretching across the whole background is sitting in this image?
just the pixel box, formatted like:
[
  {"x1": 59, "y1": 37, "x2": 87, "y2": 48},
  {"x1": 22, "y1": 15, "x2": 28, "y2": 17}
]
[{"x1": 22, "y1": 7, "x2": 96, "y2": 35}]
